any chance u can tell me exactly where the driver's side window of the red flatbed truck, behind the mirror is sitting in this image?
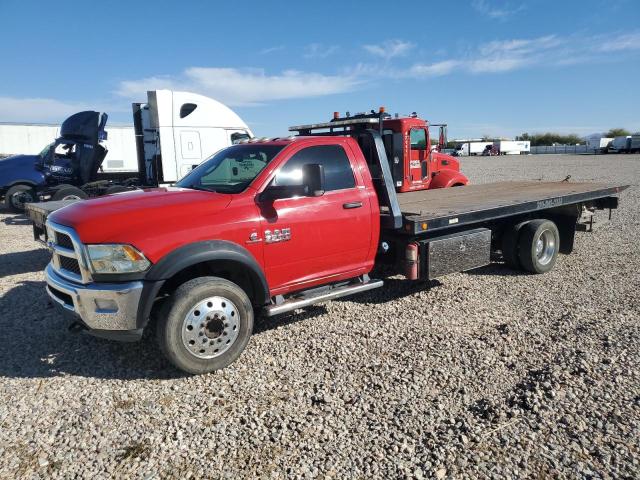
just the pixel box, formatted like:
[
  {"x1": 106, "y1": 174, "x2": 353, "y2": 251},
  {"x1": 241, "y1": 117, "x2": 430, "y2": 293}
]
[{"x1": 273, "y1": 145, "x2": 356, "y2": 191}]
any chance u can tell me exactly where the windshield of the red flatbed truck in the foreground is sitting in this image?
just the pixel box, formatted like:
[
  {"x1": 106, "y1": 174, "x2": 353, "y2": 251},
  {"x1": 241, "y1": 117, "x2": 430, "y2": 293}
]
[{"x1": 176, "y1": 144, "x2": 284, "y2": 193}]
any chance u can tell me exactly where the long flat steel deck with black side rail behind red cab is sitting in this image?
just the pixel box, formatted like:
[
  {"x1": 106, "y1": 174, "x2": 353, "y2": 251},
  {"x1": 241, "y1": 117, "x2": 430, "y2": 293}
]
[{"x1": 397, "y1": 182, "x2": 628, "y2": 234}]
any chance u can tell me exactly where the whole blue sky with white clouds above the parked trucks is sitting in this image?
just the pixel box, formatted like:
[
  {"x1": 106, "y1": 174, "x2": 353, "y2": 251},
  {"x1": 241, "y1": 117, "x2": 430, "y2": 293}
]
[{"x1": 0, "y1": 0, "x2": 640, "y2": 138}]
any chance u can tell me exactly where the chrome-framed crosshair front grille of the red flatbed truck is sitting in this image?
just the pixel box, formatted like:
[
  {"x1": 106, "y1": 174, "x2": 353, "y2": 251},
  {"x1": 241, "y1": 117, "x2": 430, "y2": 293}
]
[{"x1": 47, "y1": 222, "x2": 91, "y2": 283}]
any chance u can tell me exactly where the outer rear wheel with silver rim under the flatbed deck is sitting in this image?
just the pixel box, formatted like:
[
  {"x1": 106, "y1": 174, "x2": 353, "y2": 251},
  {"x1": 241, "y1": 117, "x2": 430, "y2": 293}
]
[{"x1": 518, "y1": 220, "x2": 560, "y2": 273}]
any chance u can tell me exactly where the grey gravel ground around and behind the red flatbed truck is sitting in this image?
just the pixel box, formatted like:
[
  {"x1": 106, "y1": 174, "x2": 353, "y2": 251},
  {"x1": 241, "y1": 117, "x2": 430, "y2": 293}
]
[{"x1": 0, "y1": 155, "x2": 640, "y2": 479}]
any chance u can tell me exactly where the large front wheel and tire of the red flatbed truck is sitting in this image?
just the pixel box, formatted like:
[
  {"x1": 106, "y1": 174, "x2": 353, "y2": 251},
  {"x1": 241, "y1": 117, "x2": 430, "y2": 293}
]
[{"x1": 157, "y1": 277, "x2": 253, "y2": 374}]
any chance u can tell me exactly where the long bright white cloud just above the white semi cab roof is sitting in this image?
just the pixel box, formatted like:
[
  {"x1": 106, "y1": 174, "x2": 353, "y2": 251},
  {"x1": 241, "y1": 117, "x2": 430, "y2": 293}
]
[{"x1": 116, "y1": 67, "x2": 361, "y2": 106}]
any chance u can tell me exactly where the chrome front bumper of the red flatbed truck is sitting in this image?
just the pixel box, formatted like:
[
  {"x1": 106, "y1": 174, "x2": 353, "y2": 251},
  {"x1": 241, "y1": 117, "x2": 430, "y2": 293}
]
[{"x1": 45, "y1": 264, "x2": 142, "y2": 330}]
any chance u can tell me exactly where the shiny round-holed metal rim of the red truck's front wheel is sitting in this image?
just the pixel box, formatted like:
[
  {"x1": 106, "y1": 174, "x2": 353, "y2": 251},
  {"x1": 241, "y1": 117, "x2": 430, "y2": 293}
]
[{"x1": 182, "y1": 297, "x2": 240, "y2": 359}]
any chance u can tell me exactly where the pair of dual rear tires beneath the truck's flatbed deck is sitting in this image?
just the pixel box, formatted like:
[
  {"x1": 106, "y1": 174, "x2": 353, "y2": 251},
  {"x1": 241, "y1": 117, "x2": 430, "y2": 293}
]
[{"x1": 502, "y1": 220, "x2": 560, "y2": 273}]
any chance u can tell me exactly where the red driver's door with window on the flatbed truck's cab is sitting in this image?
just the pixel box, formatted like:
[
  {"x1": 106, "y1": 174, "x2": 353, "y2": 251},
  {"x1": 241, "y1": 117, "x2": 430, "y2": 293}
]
[{"x1": 260, "y1": 145, "x2": 371, "y2": 290}]
